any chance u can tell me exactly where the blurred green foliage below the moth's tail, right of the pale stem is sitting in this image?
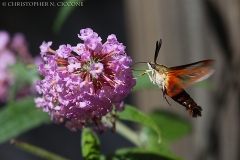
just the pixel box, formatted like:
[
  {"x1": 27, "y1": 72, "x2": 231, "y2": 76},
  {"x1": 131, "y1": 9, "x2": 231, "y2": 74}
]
[{"x1": 141, "y1": 111, "x2": 192, "y2": 155}]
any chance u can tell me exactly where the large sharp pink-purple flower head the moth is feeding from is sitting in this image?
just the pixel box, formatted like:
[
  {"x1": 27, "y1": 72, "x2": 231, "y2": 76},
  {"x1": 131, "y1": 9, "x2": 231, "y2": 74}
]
[{"x1": 35, "y1": 28, "x2": 136, "y2": 131}]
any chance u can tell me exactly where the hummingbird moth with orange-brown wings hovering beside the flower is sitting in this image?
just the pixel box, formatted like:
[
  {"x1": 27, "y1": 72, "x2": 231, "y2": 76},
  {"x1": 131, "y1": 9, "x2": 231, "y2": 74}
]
[{"x1": 139, "y1": 39, "x2": 214, "y2": 117}]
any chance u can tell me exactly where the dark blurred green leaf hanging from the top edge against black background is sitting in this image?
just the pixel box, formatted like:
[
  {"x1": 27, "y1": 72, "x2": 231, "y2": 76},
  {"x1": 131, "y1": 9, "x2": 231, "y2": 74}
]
[{"x1": 53, "y1": 0, "x2": 84, "y2": 34}]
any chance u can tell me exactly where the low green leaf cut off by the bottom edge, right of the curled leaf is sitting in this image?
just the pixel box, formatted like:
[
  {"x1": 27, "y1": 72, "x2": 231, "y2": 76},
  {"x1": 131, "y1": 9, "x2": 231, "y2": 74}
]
[{"x1": 106, "y1": 148, "x2": 181, "y2": 160}]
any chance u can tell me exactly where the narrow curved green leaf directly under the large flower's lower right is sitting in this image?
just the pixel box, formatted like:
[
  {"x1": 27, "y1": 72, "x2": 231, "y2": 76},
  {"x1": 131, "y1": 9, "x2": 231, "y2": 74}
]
[{"x1": 118, "y1": 105, "x2": 161, "y2": 141}]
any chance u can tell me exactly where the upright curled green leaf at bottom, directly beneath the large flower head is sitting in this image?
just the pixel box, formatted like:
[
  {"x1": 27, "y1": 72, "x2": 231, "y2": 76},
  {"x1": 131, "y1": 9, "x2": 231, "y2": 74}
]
[{"x1": 82, "y1": 128, "x2": 100, "y2": 160}]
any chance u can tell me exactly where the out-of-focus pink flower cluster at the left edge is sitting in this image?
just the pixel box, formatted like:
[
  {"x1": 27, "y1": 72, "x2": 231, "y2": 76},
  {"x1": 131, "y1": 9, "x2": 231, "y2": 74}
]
[{"x1": 0, "y1": 31, "x2": 42, "y2": 102}]
